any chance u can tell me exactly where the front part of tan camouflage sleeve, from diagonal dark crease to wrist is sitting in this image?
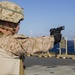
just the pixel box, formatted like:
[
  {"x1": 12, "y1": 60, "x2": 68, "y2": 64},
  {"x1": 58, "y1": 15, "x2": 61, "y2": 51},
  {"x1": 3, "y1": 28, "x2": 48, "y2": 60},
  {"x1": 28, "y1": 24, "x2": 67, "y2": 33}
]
[{"x1": 18, "y1": 36, "x2": 54, "y2": 54}]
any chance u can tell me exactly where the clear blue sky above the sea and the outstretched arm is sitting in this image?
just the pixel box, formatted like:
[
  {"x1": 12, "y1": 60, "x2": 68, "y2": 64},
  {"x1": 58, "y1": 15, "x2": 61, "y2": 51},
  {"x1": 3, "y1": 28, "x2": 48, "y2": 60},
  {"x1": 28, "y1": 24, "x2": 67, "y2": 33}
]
[{"x1": 4, "y1": 0, "x2": 75, "y2": 40}]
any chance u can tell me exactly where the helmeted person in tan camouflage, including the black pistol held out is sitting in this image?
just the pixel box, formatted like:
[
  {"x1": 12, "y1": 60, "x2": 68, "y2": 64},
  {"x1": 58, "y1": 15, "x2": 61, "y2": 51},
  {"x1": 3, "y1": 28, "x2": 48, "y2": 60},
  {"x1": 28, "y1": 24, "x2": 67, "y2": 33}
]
[{"x1": 0, "y1": 1, "x2": 64, "y2": 75}]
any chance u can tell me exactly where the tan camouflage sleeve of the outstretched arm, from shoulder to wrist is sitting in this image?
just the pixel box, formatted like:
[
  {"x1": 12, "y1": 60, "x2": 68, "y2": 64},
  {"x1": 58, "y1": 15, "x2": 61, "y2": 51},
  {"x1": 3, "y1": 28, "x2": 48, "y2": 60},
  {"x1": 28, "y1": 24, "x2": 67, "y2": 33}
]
[{"x1": 0, "y1": 35, "x2": 54, "y2": 55}]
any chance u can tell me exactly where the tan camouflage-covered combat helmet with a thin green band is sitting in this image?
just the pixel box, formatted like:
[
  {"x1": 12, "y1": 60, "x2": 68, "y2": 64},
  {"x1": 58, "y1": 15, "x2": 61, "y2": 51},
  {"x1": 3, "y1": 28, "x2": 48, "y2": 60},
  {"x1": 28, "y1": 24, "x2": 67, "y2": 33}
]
[{"x1": 0, "y1": 1, "x2": 24, "y2": 23}]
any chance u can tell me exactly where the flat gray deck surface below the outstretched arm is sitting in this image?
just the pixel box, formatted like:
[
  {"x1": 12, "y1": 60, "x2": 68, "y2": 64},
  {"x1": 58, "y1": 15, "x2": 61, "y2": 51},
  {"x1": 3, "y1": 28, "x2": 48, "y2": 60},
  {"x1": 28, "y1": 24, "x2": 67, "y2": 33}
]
[{"x1": 25, "y1": 57, "x2": 75, "y2": 75}]
